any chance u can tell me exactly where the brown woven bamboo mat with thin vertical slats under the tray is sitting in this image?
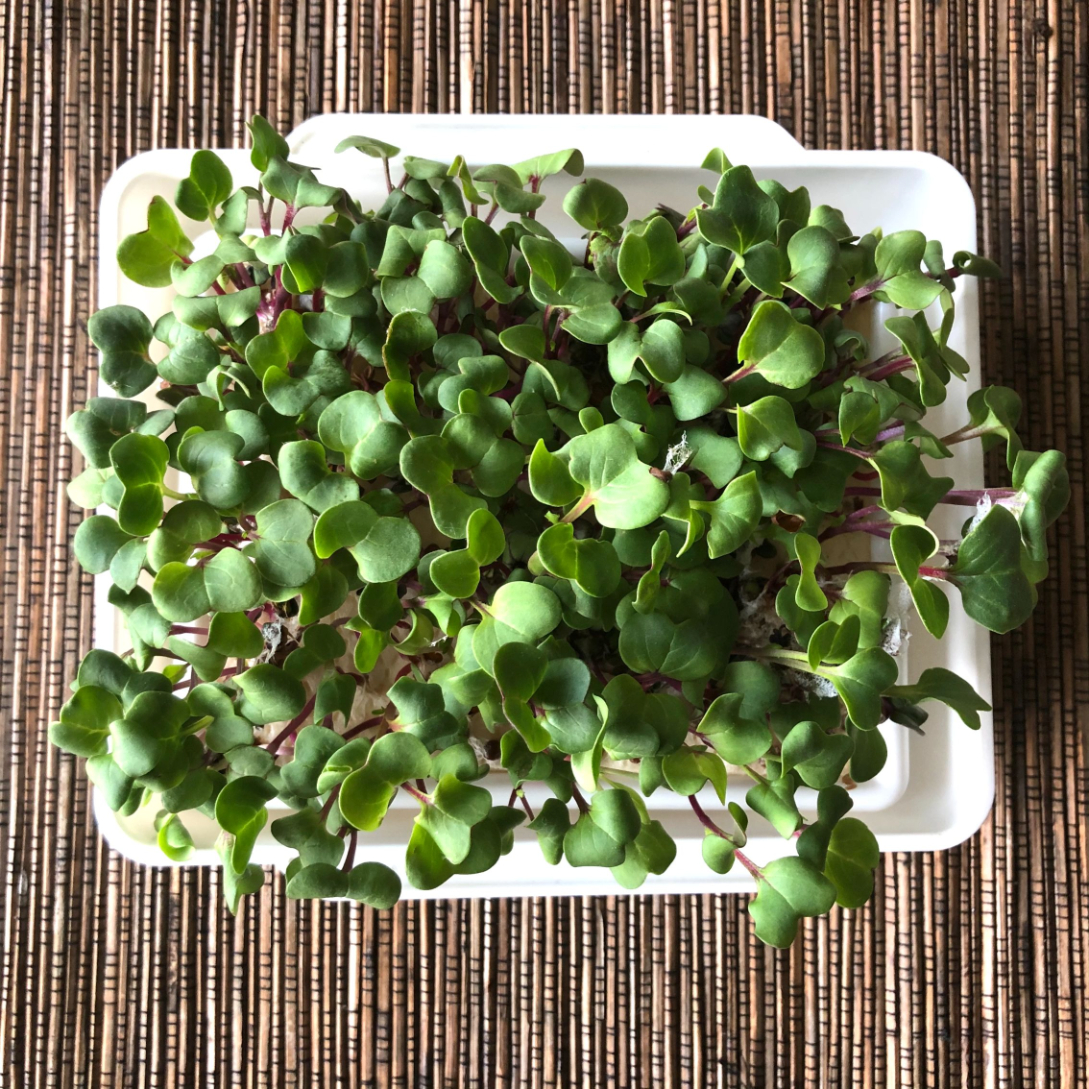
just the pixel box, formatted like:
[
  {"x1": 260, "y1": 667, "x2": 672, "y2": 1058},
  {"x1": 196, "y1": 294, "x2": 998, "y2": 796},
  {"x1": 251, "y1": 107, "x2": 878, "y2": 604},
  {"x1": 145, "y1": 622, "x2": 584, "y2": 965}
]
[{"x1": 0, "y1": 0, "x2": 1089, "y2": 1089}]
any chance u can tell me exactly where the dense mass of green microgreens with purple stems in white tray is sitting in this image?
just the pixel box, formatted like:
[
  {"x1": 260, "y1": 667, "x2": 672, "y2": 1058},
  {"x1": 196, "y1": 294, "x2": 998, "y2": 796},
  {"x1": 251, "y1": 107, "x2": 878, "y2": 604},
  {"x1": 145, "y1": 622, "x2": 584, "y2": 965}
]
[{"x1": 50, "y1": 118, "x2": 1068, "y2": 945}]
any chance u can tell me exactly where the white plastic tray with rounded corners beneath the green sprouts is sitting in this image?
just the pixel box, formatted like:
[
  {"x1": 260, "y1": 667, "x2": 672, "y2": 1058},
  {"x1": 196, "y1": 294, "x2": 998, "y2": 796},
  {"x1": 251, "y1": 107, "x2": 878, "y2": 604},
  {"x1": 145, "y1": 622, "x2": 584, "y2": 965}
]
[{"x1": 95, "y1": 114, "x2": 994, "y2": 898}]
